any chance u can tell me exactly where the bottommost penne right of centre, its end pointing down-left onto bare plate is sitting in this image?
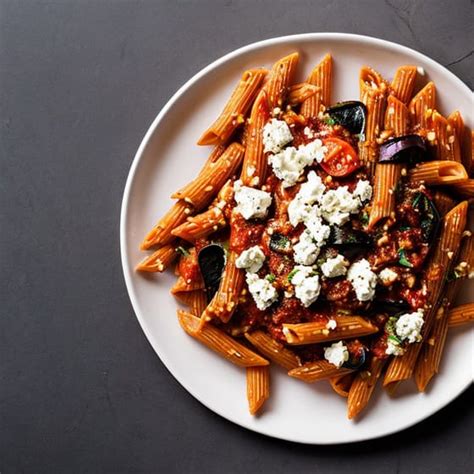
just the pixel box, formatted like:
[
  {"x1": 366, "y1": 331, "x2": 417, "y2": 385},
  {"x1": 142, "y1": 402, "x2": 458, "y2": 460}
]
[{"x1": 347, "y1": 356, "x2": 387, "y2": 419}]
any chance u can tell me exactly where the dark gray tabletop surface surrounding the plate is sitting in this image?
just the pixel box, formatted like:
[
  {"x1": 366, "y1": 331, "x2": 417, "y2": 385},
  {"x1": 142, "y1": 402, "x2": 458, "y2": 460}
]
[{"x1": 0, "y1": 0, "x2": 474, "y2": 474}]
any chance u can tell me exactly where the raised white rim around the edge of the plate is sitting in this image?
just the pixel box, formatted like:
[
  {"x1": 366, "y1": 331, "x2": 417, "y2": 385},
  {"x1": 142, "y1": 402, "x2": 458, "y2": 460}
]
[{"x1": 119, "y1": 32, "x2": 472, "y2": 446}]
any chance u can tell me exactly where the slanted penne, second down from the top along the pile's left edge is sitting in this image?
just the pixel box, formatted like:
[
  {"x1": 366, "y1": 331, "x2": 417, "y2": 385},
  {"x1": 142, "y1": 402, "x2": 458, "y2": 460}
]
[{"x1": 171, "y1": 142, "x2": 245, "y2": 211}]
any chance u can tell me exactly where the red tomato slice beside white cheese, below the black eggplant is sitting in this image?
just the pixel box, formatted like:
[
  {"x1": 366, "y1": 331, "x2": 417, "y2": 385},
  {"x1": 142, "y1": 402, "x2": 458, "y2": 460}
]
[{"x1": 320, "y1": 137, "x2": 361, "y2": 177}]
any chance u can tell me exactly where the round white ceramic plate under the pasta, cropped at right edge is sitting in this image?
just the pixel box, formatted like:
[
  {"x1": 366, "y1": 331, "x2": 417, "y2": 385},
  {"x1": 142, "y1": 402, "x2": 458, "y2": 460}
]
[{"x1": 120, "y1": 33, "x2": 474, "y2": 444}]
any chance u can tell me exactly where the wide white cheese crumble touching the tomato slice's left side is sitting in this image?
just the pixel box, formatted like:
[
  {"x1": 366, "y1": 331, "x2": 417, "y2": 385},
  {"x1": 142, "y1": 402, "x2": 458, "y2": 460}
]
[{"x1": 268, "y1": 139, "x2": 327, "y2": 188}]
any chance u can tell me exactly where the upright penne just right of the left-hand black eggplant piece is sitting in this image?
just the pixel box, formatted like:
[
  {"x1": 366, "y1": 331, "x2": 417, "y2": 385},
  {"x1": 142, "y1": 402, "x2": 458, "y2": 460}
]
[{"x1": 202, "y1": 250, "x2": 245, "y2": 323}]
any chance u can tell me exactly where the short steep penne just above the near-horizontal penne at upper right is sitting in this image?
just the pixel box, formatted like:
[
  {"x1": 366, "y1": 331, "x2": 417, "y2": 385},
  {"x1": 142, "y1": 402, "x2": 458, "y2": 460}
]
[{"x1": 426, "y1": 110, "x2": 461, "y2": 162}]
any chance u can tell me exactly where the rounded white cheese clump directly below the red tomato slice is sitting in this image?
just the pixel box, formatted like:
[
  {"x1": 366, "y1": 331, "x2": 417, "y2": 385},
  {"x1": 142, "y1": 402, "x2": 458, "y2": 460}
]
[{"x1": 320, "y1": 186, "x2": 361, "y2": 226}]
